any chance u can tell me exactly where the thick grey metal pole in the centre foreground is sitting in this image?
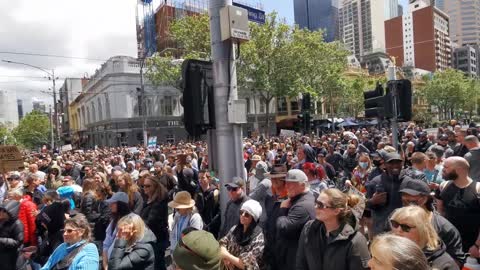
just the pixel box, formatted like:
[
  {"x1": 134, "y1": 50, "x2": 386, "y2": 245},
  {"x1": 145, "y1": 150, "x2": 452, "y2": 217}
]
[{"x1": 209, "y1": 0, "x2": 244, "y2": 222}]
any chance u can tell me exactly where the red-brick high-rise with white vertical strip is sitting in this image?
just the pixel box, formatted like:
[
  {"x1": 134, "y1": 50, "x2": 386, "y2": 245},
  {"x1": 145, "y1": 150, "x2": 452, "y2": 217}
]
[{"x1": 385, "y1": 1, "x2": 452, "y2": 71}]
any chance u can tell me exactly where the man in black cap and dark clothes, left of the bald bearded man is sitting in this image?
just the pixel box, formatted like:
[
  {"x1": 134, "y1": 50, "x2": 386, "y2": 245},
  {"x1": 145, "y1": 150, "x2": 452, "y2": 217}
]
[{"x1": 366, "y1": 152, "x2": 411, "y2": 236}]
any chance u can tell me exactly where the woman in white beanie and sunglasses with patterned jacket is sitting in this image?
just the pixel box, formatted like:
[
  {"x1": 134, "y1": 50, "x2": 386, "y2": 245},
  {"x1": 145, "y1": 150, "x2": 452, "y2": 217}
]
[{"x1": 219, "y1": 200, "x2": 265, "y2": 270}]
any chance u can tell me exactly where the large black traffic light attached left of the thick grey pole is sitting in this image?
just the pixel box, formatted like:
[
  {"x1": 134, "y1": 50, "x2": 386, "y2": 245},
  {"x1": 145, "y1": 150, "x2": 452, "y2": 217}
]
[{"x1": 180, "y1": 59, "x2": 215, "y2": 138}]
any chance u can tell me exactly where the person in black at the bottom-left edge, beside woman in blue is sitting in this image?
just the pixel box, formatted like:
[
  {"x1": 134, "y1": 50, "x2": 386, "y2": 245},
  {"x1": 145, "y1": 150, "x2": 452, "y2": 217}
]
[{"x1": 0, "y1": 201, "x2": 23, "y2": 270}]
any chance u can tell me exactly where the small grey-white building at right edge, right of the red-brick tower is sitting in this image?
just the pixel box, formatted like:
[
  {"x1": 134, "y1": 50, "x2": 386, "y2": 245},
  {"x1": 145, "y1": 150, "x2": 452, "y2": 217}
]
[{"x1": 452, "y1": 45, "x2": 480, "y2": 77}]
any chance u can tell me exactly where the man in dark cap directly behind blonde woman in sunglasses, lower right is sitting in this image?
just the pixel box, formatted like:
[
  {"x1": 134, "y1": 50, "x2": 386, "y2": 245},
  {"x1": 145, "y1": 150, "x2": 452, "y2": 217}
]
[{"x1": 400, "y1": 179, "x2": 465, "y2": 265}]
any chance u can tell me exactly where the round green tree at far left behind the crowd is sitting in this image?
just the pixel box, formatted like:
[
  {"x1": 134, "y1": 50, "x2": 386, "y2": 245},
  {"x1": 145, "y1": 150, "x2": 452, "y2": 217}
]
[{"x1": 12, "y1": 111, "x2": 50, "y2": 149}]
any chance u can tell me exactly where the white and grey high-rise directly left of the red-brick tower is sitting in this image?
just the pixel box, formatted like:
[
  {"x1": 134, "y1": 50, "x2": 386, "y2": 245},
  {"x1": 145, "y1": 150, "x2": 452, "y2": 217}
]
[{"x1": 338, "y1": 0, "x2": 386, "y2": 60}]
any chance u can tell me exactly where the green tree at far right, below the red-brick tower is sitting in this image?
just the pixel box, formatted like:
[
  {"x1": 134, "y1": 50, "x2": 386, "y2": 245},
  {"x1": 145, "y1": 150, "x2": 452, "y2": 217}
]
[{"x1": 422, "y1": 69, "x2": 474, "y2": 120}]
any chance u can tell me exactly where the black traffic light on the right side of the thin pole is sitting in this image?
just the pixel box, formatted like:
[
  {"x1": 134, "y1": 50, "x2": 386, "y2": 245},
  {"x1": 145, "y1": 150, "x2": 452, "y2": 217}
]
[{"x1": 385, "y1": 80, "x2": 412, "y2": 122}]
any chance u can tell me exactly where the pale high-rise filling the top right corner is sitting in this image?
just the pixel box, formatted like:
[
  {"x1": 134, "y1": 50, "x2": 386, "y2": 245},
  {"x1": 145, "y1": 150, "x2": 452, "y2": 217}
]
[{"x1": 438, "y1": 0, "x2": 480, "y2": 47}]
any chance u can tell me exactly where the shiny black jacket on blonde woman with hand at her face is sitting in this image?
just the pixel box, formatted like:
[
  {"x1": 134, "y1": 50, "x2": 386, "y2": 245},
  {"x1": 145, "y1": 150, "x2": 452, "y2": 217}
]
[{"x1": 108, "y1": 228, "x2": 156, "y2": 270}]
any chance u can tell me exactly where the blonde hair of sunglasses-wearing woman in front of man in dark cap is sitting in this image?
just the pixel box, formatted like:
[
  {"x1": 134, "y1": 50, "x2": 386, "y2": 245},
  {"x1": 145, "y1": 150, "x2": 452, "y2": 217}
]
[{"x1": 391, "y1": 205, "x2": 440, "y2": 250}]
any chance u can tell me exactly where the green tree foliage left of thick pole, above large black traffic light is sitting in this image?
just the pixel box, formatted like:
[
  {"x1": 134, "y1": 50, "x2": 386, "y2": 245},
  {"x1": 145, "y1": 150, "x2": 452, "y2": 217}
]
[{"x1": 145, "y1": 14, "x2": 211, "y2": 88}]
